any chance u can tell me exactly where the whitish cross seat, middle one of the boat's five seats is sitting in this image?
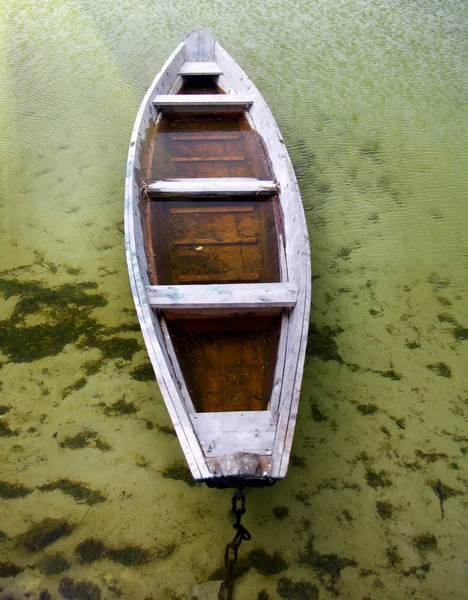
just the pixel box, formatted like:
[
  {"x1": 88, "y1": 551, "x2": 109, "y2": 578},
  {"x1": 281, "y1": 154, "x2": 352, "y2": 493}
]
[{"x1": 146, "y1": 178, "x2": 278, "y2": 196}]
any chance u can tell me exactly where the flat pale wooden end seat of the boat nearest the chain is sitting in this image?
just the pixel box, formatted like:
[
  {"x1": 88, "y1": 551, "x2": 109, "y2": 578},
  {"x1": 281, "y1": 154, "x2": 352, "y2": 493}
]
[{"x1": 190, "y1": 410, "x2": 278, "y2": 457}]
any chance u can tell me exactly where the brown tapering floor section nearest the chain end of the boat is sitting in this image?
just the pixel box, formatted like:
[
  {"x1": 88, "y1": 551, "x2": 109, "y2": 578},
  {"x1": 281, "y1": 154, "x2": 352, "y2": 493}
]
[{"x1": 168, "y1": 315, "x2": 281, "y2": 412}]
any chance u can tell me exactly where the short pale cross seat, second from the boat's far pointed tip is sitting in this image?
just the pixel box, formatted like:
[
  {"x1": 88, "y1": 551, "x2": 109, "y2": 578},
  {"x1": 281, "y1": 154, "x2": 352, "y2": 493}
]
[{"x1": 153, "y1": 94, "x2": 253, "y2": 113}]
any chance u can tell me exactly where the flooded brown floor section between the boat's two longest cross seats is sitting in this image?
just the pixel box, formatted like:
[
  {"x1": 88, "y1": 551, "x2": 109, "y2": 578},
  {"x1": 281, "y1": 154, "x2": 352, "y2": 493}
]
[{"x1": 149, "y1": 199, "x2": 279, "y2": 284}]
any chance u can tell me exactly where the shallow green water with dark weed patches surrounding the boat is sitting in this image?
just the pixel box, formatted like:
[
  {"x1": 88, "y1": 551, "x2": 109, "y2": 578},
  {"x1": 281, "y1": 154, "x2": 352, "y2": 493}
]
[{"x1": 0, "y1": 0, "x2": 468, "y2": 600}]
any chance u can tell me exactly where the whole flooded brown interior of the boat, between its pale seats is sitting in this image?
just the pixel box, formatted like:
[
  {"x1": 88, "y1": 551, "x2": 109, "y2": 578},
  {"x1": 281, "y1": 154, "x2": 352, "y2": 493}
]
[{"x1": 144, "y1": 75, "x2": 287, "y2": 412}]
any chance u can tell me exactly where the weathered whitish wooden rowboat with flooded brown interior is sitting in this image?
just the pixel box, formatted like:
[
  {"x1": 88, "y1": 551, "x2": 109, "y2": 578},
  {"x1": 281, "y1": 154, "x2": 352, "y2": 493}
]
[{"x1": 125, "y1": 30, "x2": 311, "y2": 487}]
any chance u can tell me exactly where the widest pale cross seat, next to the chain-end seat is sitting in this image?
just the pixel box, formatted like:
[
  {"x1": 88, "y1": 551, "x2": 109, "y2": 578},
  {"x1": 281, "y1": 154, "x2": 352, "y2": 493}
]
[{"x1": 146, "y1": 283, "x2": 298, "y2": 309}]
